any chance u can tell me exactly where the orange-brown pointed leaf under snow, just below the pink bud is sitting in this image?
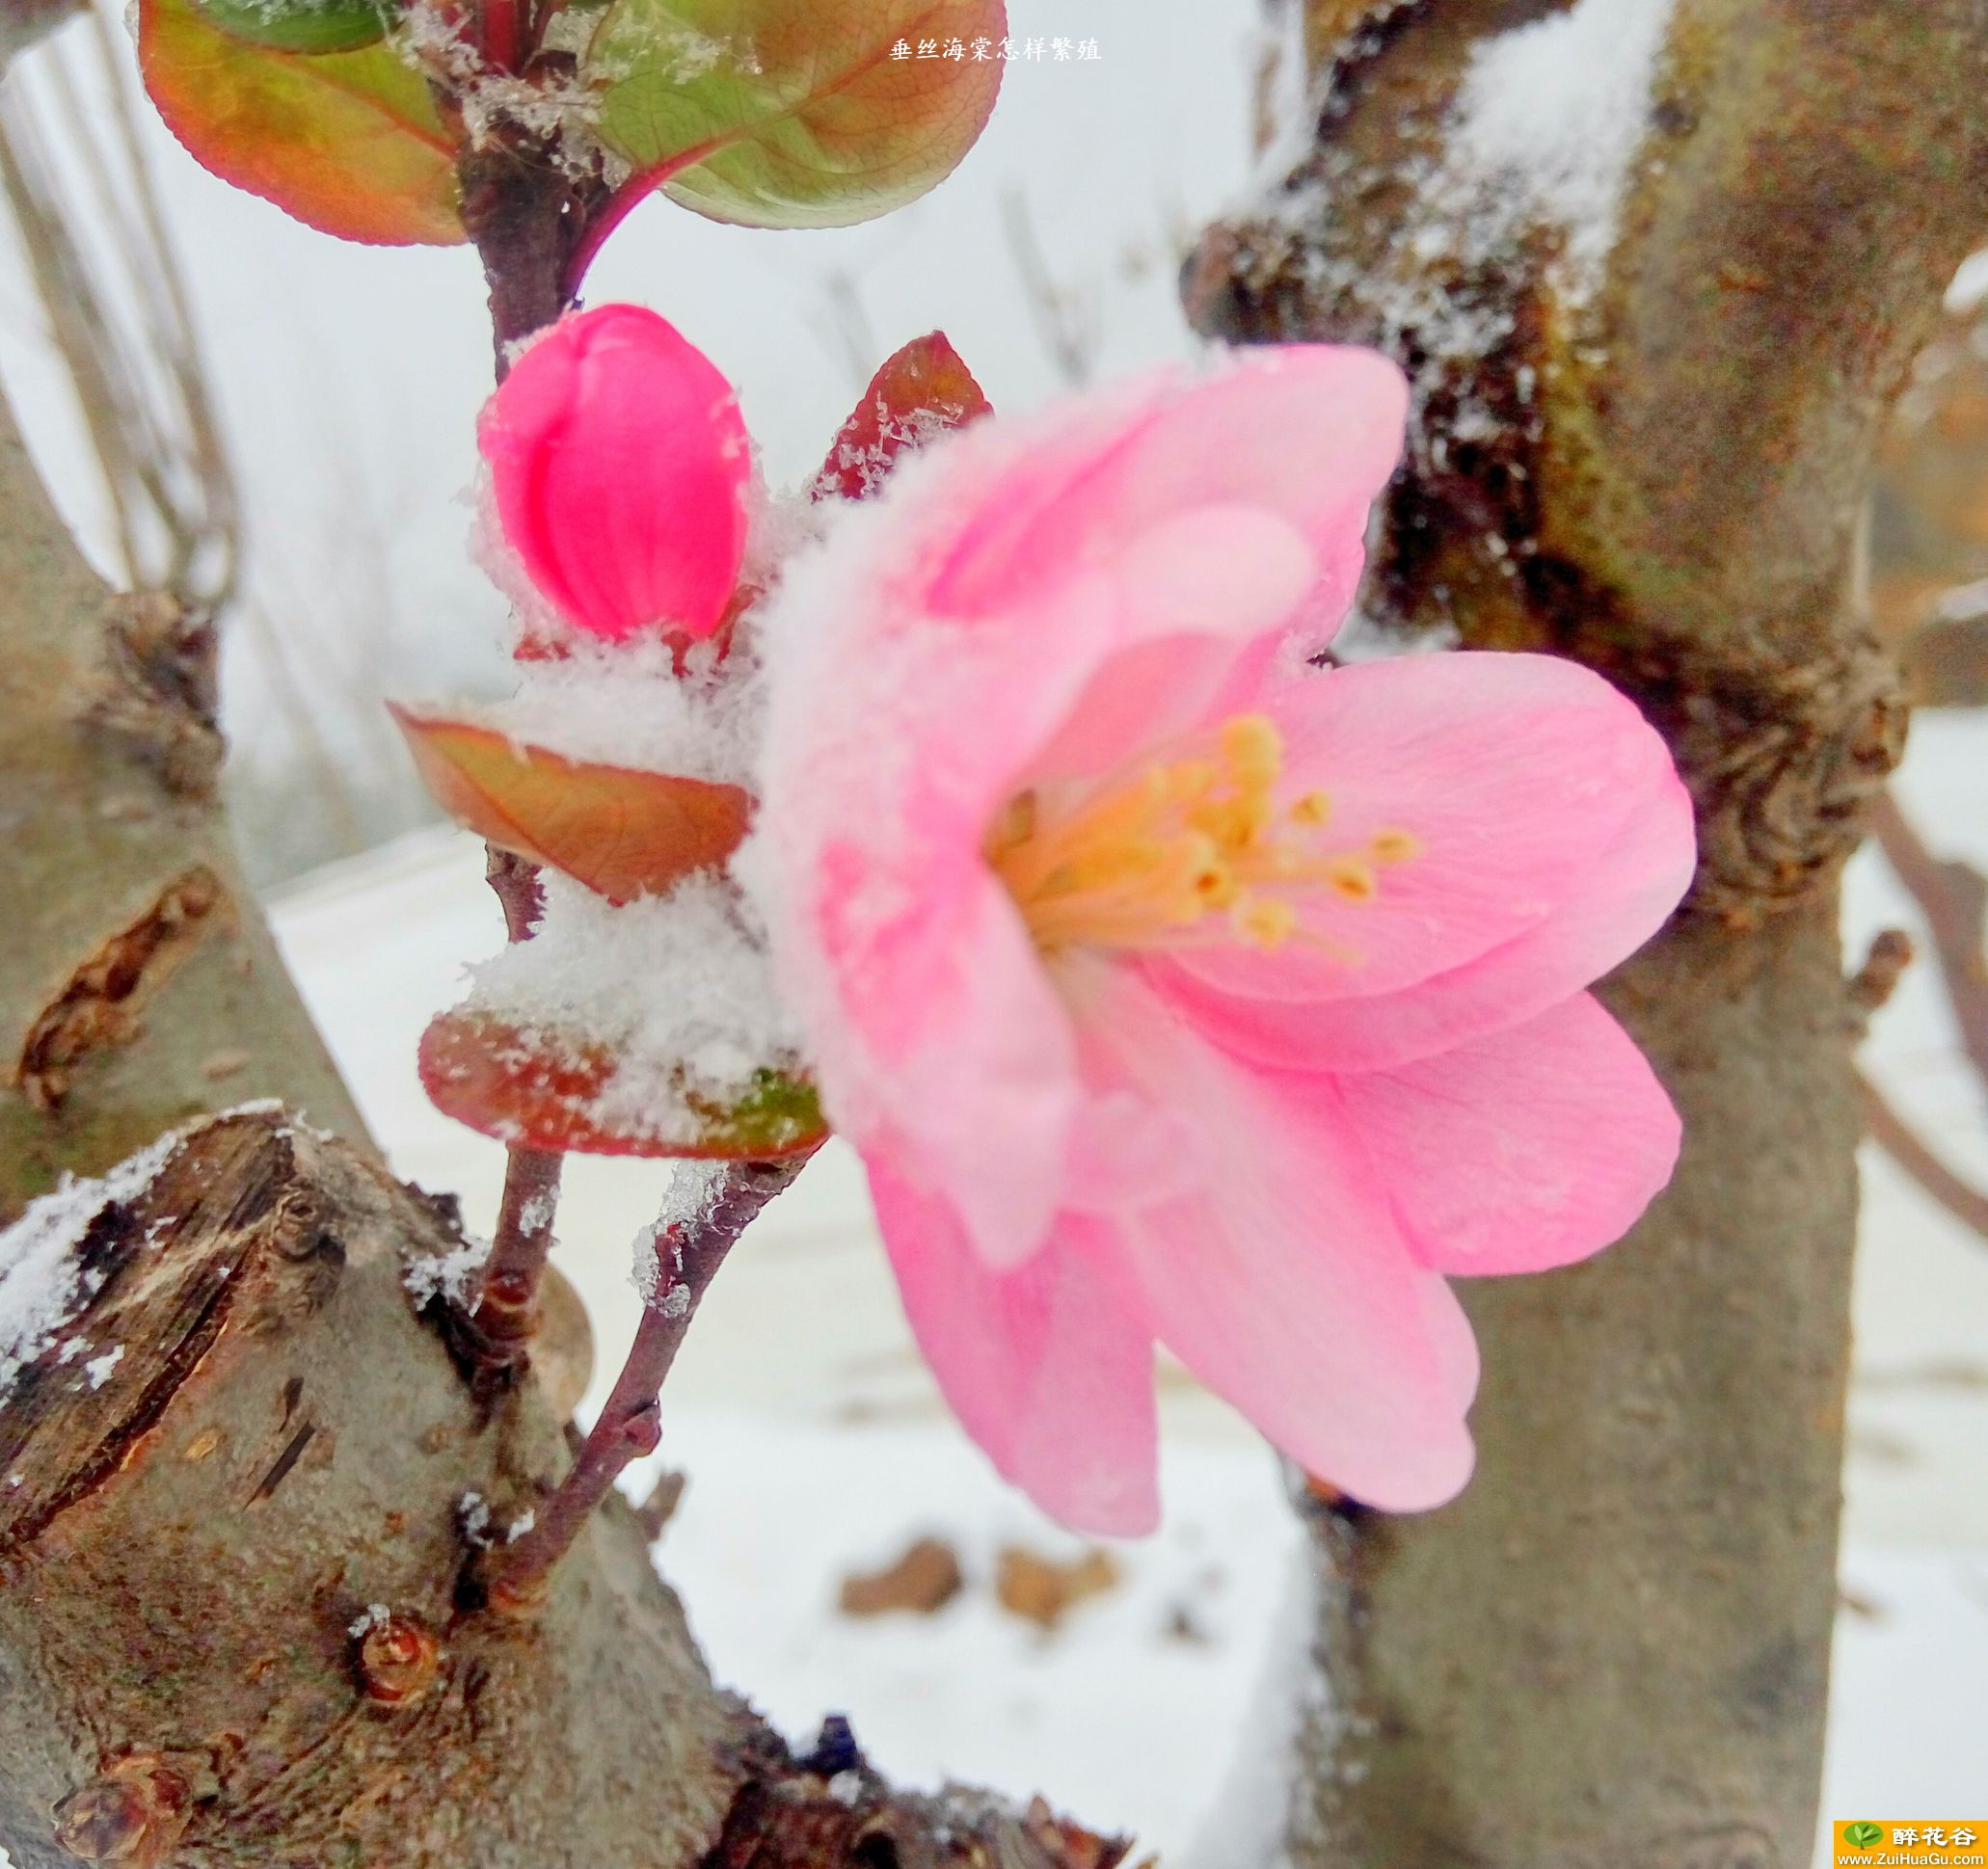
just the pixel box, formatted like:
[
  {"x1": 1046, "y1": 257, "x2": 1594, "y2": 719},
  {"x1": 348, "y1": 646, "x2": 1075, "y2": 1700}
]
[{"x1": 391, "y1": 708, "x2": 751, "y2": 902}]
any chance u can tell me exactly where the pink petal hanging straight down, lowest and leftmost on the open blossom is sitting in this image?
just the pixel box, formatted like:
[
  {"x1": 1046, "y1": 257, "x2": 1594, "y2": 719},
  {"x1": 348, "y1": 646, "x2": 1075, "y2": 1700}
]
[{"x1": 869, "y1": 1151, "x2": 1159, "y2": 1537}]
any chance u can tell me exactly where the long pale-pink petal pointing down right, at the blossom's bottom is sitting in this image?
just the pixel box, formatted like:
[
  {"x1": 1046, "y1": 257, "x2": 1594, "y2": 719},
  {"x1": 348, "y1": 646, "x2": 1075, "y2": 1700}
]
[{"x1": 1088, "y1": 969, "x2": 1475, "y2": 1511}]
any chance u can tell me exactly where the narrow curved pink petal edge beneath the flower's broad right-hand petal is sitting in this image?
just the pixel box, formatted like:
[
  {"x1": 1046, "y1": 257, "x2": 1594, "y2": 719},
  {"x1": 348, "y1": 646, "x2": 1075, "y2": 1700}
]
[{"x1": 1147, "y1": 780, "x2": 1698, "y2": 1072}]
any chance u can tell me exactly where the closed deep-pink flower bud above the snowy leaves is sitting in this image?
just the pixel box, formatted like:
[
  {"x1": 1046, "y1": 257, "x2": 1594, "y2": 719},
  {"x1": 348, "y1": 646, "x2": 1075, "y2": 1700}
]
[{"x1": 477, "y1": 305, "x2": 751, "y2": 642}]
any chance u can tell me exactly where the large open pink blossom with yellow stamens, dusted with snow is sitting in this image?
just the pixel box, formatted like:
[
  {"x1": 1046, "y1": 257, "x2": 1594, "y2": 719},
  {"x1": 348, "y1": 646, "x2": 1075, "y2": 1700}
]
[{"x1": 745, "y1": 348, "x2": 1694, "y2": 1533}]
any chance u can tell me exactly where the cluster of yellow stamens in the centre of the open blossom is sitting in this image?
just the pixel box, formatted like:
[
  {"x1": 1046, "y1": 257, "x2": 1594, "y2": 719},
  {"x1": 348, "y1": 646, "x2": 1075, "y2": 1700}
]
[{"x1": 986, "y1": 714, "x2": 1421, "y2": 964}]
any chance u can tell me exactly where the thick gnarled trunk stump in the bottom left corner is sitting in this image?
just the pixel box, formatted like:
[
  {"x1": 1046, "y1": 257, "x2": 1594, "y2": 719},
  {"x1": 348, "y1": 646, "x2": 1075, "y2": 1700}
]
[{"x1": 0, "y1": 1113, "x2": 1115, "y2": 1869}]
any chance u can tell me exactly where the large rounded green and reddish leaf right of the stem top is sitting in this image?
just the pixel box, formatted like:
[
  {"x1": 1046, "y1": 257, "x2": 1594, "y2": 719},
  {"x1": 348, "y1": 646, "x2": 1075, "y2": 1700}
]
[{"x1": 588, "y1": 0, "x2": 1007, "y2": 227}]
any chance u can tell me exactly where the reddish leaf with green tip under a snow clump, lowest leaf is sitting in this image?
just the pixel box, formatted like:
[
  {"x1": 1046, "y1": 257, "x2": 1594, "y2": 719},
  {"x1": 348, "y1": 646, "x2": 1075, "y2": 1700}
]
[{"x1": 421, "y1": 1010, "x2": 829, "y2": 1161}]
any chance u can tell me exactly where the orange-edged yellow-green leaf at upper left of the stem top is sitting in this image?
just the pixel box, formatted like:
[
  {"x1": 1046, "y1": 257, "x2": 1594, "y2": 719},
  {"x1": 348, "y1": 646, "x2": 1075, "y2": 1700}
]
[{"x1": 137, "y1": 0, "x2": 463, "y2": 247}]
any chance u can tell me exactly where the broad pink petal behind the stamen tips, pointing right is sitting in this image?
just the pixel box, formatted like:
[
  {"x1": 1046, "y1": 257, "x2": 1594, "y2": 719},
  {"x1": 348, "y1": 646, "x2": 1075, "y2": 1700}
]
[{"x1": 1181, "y1": 653, "x2": 1678, "y2": 1001}]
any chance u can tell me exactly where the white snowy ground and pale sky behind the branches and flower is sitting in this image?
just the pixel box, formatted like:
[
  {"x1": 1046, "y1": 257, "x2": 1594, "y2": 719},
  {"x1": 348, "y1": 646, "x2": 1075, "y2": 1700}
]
[{"x1": 0, "y1": 0, "x2": 1988, "y2": 1869}]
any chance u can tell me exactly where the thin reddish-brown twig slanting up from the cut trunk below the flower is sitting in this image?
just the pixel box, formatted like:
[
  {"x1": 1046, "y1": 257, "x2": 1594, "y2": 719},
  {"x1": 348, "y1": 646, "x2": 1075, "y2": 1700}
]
[{"x1": 489, "y1": 1161, "x2": 801, "y2": 1611}]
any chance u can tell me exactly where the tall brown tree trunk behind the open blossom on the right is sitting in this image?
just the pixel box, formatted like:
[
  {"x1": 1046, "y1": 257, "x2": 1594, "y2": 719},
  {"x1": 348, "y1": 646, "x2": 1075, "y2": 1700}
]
[{"x1": 1187, "y1": 0, "x2": 1988, "y2": 1869}]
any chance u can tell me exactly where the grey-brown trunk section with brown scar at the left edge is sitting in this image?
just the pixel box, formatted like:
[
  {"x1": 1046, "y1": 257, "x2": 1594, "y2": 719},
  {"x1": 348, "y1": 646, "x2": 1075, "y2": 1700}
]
[{"x1": 0, "y1": 389, "x2": 365, "y2": 1223}]
